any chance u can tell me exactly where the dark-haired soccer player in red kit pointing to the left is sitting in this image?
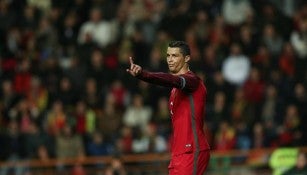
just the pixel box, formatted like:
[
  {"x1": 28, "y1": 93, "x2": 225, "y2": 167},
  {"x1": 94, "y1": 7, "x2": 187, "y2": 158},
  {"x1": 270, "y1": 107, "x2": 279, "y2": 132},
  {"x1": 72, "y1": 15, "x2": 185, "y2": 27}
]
[{"x1": 127, "y1": 41, "x2": 210, "y2": 175}]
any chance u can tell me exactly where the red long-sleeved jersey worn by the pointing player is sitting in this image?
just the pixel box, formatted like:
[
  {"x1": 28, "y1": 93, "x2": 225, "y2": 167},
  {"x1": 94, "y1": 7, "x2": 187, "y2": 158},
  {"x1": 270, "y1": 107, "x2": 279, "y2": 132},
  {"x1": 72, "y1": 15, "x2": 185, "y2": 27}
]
[{"x1": 137, "y1": 71, "x2": 210, "y2": 156}]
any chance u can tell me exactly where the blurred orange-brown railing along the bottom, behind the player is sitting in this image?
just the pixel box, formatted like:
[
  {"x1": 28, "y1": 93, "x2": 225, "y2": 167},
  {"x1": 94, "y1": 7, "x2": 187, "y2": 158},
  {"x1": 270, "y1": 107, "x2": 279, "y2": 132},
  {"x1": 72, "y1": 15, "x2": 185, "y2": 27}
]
[{"x1": 0, "y1": 147, "x2": 307, "y2": 175}]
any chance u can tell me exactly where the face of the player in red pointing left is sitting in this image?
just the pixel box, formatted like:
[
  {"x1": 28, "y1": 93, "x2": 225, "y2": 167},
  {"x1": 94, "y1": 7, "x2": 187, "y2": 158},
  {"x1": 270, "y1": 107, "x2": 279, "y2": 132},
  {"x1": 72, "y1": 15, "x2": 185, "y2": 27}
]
[{"x1": 166, "y1": 47, "x2": 185, "y2": 74}]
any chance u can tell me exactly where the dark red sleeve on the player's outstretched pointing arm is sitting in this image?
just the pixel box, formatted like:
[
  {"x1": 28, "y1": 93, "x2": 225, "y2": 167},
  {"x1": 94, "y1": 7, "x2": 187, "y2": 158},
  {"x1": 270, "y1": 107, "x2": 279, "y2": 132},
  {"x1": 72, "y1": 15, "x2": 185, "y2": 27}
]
[{"x1": 137, "y1": 70, "x2": 199, "y2": 92}]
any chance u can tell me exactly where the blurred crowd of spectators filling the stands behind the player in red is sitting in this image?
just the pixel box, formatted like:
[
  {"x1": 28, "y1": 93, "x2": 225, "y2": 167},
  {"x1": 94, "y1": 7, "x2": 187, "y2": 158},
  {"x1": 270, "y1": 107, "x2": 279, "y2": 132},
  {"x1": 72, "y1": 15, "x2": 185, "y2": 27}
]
[{"x1": 0, "y1": 0, "x2": 307, "y2": 169}]
